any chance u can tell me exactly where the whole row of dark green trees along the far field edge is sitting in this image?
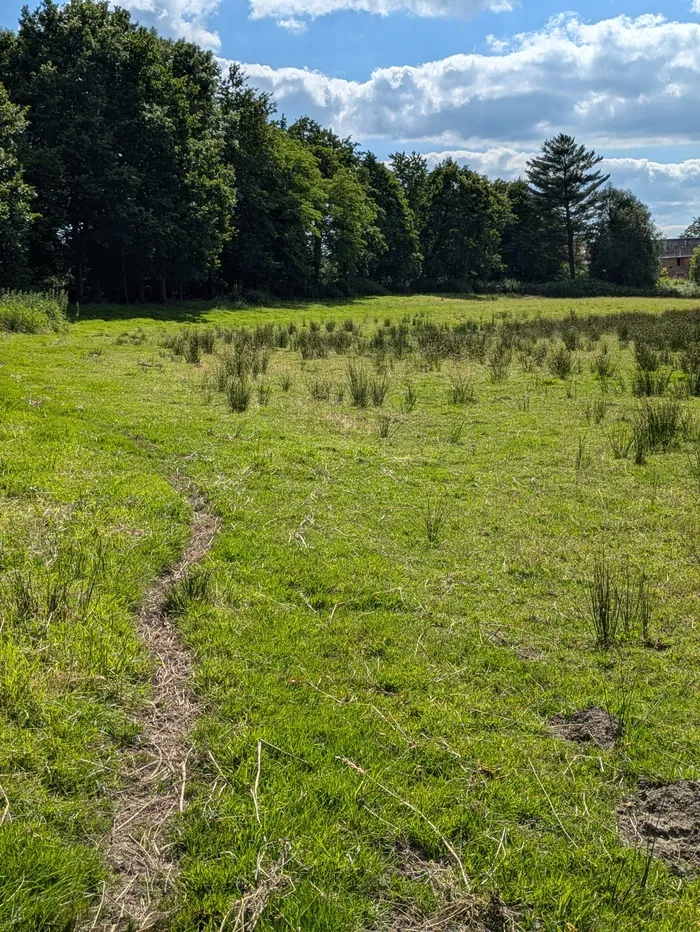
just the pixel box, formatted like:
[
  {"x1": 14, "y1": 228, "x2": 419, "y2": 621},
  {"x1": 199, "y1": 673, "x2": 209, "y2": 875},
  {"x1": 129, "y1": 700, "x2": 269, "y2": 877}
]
[{"x1": 0, "y1": 0, "x2": 659, "y2": 302}]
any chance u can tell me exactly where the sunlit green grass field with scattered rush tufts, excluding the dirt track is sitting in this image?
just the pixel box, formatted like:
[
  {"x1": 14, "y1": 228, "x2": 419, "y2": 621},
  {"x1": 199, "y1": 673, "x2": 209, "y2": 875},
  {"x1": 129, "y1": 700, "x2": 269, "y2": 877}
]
[{"x1": 0, "y1": 297, "x2": 700, "y2": 932}]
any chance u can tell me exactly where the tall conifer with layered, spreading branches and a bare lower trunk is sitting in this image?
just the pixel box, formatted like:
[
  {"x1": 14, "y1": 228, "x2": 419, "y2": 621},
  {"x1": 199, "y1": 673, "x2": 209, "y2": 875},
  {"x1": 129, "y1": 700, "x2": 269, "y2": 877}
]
[{"x1": 527, "y1": 133, "x2": 610, "y2": 278}]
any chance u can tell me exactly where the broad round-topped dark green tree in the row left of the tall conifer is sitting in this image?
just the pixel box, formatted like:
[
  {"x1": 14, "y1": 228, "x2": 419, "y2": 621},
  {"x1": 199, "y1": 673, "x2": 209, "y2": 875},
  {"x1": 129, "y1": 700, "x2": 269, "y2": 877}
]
[{"x1": 422, "y1": 159, "x2": 509, "y2": 284}]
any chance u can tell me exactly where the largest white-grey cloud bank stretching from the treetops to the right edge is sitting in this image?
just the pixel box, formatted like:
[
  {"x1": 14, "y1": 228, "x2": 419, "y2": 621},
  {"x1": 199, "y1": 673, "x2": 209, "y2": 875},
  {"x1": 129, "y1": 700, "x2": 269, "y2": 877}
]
[{"x1": 239, "y1": 13, "x2": 700, "y2": 148}]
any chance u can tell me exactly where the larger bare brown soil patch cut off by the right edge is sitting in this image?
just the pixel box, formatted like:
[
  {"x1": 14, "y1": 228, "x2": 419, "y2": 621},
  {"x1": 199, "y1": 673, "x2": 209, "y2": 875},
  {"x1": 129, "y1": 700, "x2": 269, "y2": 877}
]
[{"x1": 616, "y1": 780, "x2": 700, "y2": 875}]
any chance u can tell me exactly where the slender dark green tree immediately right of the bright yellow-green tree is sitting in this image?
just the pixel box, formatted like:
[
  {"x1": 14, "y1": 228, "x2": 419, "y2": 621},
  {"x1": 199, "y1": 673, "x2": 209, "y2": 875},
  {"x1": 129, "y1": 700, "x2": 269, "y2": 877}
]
[{"x1": 360, "y1": 152, "x2": 421, "y2": 288}]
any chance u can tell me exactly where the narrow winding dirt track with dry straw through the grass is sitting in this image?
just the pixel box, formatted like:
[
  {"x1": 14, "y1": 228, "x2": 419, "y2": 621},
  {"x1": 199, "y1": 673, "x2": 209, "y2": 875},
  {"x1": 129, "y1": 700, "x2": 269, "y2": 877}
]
[{"x1": 86, "y1": 476, "x2": 219, "y2": 932}]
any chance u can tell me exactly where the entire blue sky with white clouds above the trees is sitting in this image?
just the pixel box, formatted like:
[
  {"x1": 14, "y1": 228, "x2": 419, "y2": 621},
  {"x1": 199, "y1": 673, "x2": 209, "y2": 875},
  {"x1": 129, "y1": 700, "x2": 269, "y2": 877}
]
[{"x1": 0, "y1": 0, "x2": 700, "y2": 235}]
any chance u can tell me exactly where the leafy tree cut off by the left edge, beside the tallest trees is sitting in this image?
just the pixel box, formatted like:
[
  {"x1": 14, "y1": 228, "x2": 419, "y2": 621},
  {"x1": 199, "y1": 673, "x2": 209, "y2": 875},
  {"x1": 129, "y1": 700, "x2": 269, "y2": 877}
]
[{"x1": 0, "y1": 84, "x2": 35, "y2": 288}]
